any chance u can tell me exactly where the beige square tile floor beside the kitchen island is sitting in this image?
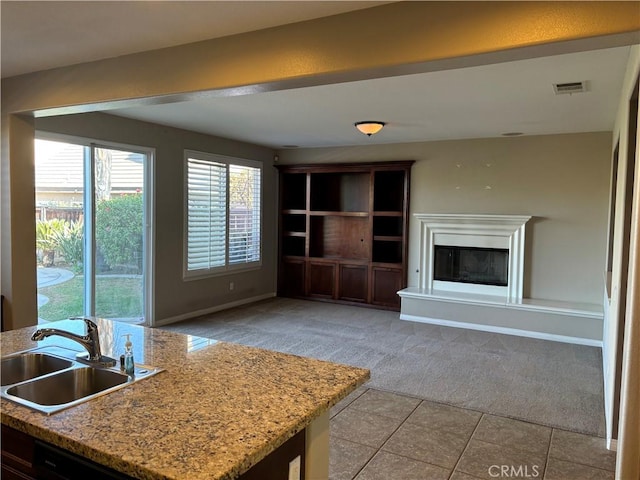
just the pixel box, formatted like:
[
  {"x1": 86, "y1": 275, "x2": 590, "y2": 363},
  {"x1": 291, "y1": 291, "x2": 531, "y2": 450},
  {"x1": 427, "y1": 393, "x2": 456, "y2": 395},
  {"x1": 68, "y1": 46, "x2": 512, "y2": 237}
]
[{"x1": 330, "y1": 387, "x2": 615, "y2": 480}]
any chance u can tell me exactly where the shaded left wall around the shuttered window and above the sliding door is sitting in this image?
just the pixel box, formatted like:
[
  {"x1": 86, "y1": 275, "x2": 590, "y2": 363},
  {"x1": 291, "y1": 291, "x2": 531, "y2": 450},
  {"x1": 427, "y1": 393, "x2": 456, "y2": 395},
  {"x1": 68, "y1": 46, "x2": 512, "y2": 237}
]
[{"x1": 36, "y1": 113, "x2": 277, "y2": 322}]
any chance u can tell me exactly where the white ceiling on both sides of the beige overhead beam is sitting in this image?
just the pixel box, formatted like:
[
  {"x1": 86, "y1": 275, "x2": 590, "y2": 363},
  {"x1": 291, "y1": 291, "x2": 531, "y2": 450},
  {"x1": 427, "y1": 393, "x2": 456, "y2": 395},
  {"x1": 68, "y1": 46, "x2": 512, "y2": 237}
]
[{"x1": 1, "y1": 0, "x2": 630, "y2": 149}]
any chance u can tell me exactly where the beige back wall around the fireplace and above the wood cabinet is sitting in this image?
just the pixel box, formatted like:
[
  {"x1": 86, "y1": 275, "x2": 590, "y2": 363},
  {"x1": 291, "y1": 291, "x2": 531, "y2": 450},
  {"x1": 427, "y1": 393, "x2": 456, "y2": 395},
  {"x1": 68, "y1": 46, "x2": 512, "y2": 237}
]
[{"x1": 279, "y1": 132, "x2": 611, "y2": 304}]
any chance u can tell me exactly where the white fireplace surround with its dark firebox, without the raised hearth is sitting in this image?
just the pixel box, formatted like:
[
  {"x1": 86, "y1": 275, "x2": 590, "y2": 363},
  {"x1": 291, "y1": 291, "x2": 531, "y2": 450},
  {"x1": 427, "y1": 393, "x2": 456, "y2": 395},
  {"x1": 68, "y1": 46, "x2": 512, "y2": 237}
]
[{"x1": 414, "y1": 214, "x2": 531, "y2": 302}]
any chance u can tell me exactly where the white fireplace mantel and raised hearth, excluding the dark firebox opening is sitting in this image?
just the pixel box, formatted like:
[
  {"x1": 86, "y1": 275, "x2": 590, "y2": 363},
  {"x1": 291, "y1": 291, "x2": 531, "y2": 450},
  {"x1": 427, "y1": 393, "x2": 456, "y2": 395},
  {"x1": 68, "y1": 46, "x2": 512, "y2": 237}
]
[{"x1": 398, "y1": 213, "x2": 603, "y2": 347}]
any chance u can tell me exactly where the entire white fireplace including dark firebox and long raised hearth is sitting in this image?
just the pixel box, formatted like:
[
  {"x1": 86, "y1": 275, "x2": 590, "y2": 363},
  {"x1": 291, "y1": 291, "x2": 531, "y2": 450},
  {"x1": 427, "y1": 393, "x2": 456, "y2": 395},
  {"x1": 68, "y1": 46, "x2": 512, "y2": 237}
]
[{"x1": 398, "y1": 213, "x2": 606, "y2": 346}]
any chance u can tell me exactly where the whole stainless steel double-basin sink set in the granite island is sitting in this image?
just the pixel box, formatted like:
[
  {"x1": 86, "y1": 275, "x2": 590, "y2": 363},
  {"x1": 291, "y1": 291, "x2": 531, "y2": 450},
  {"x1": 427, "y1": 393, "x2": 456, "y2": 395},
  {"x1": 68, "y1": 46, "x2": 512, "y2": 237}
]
[{"x1": 0, "y1": 346, "x2": 162, "y2": 415}]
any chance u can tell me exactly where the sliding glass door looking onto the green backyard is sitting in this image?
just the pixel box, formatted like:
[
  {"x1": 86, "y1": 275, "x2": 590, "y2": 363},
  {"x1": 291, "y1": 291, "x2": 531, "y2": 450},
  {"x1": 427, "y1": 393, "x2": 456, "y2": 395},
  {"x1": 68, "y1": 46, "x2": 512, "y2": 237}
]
[{"x1": 36, "y1": 139, "x2": 150, "y2": 323}]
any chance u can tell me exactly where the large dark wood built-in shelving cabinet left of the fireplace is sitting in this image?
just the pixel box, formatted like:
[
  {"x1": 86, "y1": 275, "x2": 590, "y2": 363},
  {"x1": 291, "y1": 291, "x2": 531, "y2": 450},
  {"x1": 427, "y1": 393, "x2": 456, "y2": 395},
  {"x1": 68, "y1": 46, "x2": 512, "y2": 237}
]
[{"x1": 278, "y1": 161, "x2": 413, "y2": 309}]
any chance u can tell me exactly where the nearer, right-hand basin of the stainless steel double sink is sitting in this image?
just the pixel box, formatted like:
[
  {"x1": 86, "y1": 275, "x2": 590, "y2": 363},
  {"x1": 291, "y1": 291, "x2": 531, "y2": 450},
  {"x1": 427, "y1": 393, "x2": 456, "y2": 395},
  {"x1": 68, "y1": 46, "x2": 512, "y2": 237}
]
[{"x1": 7, "y1": 367, "x2": 129, "y2": 406}]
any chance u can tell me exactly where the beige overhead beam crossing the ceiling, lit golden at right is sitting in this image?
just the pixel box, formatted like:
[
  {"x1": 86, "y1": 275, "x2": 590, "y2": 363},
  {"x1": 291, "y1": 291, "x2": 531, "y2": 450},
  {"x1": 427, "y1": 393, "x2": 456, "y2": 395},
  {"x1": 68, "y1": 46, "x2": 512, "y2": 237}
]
[{"x1": 2, "y1": 1, "x2": 640, "y2": 114}]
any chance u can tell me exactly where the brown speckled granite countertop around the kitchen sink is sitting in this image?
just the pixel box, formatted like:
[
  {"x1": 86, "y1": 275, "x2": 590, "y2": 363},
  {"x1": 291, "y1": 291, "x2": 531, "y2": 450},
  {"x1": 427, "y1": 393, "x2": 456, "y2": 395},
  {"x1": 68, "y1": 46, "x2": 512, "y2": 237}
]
[{"x1": 0, "y1": 319, "x2": 369, "y2": 480}]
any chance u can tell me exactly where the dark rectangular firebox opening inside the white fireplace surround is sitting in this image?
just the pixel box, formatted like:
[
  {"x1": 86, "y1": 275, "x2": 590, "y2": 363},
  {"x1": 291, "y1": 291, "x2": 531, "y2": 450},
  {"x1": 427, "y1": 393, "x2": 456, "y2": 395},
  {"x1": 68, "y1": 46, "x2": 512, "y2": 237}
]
[{"x1": 433, "y1": 245, "x2": 509, "y2": 287}]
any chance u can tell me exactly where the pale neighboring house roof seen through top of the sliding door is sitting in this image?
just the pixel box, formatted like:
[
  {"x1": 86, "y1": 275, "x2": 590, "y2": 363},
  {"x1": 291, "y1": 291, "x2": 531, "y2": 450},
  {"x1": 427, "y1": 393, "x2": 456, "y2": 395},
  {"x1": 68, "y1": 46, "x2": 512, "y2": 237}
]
[{"x1": 35, "y1": 145, "x2": 144, "y2": 192}]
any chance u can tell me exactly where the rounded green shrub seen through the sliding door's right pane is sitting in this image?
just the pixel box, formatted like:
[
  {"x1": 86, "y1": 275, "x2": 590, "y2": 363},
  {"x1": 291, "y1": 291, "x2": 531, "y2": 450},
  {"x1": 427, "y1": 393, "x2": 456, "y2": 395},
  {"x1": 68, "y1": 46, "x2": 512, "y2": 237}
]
[{"x1": 96, "y1": 194, "x2": 143, "y2": 273}]
